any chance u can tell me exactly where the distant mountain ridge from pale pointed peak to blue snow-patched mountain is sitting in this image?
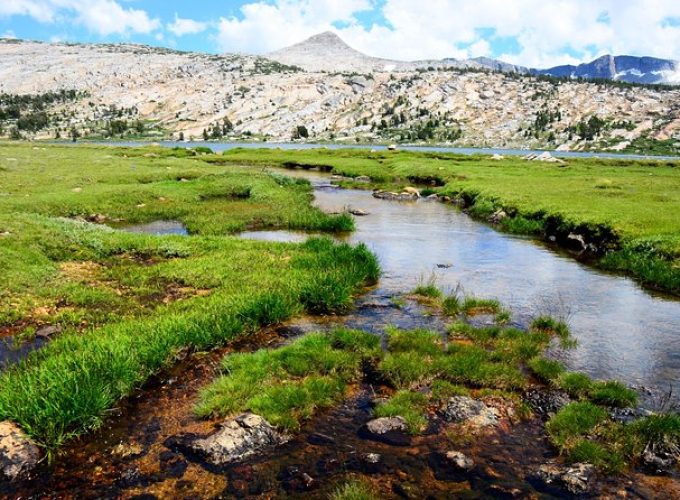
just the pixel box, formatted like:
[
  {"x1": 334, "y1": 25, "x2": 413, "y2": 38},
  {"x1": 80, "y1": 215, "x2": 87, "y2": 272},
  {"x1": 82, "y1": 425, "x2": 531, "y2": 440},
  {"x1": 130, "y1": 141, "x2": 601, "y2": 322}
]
[{"x1": 267, "y1": 31, "x2": 680, "y2": 84}]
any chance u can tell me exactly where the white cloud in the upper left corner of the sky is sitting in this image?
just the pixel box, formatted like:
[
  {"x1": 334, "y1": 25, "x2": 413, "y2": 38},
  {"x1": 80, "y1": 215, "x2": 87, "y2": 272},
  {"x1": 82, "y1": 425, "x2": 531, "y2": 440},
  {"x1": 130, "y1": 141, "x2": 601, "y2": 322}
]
[{"x1": 0, "y1": 0, "x2": 160, "y2": 36}]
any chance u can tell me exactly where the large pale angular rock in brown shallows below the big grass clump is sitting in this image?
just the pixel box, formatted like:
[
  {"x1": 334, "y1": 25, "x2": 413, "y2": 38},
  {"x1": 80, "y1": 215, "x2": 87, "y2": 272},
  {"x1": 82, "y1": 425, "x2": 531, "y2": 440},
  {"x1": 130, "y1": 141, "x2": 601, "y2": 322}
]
[{"x1": 171, "y1": 413, "x2": 288, "y2": 466}]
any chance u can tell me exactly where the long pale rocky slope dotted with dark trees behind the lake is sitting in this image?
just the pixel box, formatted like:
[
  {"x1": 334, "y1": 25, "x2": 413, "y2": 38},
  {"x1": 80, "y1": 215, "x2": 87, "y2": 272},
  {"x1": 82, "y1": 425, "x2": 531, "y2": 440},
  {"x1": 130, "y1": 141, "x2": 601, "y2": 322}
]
[{"x1": 0, "y1": 40, "x2": 680, "y2": 149}]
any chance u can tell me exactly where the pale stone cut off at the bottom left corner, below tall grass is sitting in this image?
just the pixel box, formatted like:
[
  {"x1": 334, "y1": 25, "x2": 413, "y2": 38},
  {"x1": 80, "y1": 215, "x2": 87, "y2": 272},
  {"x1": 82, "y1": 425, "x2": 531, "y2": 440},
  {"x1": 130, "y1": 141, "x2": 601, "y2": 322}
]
[{"x1": 0, "y1": 422, "x2": 40, "y2": 481}]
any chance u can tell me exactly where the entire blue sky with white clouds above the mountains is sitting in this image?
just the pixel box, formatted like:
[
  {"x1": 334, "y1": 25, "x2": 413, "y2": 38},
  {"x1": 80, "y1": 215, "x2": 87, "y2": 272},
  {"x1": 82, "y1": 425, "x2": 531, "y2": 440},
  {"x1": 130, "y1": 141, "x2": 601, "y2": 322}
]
[{"x1": 0, "y1": 0, "x2": 680, "y2": 67}]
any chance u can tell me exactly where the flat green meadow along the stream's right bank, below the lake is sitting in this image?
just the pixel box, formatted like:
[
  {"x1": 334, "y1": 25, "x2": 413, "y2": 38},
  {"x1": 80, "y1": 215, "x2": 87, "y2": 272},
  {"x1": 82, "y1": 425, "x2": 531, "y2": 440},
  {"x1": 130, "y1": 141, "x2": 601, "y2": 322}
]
[{"x1": 207, "y1": 148, "x2": 680, "y2": 294}]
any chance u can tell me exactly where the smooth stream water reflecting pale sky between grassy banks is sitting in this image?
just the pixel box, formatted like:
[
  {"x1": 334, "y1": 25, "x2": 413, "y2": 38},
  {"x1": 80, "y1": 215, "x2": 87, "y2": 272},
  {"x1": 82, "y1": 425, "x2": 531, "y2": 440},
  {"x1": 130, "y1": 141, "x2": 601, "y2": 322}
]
[{"x1": 286, "y1": 172, "x2": 680, "y2": 393}]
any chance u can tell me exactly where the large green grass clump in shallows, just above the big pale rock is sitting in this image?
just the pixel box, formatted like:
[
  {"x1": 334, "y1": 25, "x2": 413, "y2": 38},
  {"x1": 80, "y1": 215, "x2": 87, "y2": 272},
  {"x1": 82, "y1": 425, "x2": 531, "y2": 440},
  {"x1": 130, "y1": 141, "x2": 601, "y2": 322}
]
[{"x1": 195, "y1": 330, "x2": 376, "y2": 431}]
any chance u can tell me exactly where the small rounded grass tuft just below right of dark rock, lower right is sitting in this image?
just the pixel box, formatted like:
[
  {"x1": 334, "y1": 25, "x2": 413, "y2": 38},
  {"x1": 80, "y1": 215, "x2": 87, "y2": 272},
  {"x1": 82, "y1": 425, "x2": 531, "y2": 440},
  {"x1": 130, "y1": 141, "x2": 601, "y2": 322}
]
[{"x1": 545, "y1": 402, "x2": 608, "y2": 449}]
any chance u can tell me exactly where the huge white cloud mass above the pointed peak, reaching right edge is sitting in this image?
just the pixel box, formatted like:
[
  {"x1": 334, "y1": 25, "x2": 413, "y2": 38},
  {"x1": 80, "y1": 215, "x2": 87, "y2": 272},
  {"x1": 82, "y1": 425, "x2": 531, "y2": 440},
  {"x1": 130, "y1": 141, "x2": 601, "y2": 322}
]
[{"x1": 217, "y1": 0, "x2": 680, "y2": 67}]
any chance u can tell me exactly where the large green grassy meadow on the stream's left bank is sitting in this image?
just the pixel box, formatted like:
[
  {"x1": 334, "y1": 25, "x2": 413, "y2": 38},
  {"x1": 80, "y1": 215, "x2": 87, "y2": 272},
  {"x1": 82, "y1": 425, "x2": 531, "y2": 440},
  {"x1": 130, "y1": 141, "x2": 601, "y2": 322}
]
[{"x1": 0, "y1": 145, "x2": 379, "y2": 454}]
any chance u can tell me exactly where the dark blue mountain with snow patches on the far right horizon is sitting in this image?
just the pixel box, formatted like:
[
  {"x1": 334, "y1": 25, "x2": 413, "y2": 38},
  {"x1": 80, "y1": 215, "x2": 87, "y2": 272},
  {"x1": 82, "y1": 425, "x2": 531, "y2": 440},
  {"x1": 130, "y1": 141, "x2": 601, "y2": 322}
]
[{"x1": 533, "y1": 55, "x2": 680, "y2": 83}]
